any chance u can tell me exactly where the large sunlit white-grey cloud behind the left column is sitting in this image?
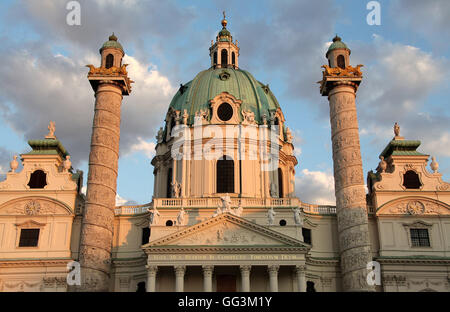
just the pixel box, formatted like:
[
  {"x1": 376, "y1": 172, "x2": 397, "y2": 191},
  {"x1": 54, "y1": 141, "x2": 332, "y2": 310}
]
[{"x1": 0, "y1": 44, "x2": 176, "y2": 165}]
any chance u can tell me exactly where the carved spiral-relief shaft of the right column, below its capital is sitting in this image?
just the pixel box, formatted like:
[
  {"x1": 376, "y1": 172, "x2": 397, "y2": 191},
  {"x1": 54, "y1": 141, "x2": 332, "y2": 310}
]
[{"x1": 328, "y1": 78, "x2": 374, "y2": 291}]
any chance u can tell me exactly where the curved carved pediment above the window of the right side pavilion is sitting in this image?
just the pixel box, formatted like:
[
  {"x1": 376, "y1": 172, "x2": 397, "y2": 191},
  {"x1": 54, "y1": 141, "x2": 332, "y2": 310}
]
[{"x1": 376, "y1": 196, "x2": 450, "y2": 216}]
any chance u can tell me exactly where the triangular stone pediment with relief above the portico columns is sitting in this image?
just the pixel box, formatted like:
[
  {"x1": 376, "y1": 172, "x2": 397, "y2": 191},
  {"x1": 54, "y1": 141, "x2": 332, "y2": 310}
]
[{"x1": 143, "y1": 213, "x2": 309, "y2": 248}]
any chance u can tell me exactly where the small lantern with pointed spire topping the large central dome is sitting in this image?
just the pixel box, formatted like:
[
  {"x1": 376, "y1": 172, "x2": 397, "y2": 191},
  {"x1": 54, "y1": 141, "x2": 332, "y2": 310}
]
[{"x1": 209, "y1": 11, "x2": 239, "y2": 68}]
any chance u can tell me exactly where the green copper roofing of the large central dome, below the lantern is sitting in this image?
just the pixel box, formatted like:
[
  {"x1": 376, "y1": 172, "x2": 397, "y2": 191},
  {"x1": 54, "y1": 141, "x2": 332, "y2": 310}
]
[{"x1": 170, "y1": 67, "x2": 280, "y2": 124}]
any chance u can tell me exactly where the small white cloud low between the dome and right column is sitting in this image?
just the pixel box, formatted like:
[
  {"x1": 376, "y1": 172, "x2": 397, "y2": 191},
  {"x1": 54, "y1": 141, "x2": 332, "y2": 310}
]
[{"x1": 295, "y1": 169, "x2": 336, "y2": 205}]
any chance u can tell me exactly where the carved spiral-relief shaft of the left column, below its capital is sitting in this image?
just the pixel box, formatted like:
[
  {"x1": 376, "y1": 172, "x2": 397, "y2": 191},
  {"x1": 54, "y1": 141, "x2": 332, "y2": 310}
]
[{"x1": 78, "y1": 81, "x2": 122, "y2": 291}]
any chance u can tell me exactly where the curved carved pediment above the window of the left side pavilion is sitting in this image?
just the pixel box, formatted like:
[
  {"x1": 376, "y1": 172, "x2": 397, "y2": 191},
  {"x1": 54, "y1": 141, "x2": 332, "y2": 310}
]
[{"x1": 0, "y1": 196, "x2": 73, "y2": 216}]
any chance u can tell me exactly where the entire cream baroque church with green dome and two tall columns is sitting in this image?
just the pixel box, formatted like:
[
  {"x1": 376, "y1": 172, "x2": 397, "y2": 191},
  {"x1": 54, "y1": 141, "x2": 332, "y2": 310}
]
[{"x1": 0, "y1": 17, "x2": 450, "y2": 292}]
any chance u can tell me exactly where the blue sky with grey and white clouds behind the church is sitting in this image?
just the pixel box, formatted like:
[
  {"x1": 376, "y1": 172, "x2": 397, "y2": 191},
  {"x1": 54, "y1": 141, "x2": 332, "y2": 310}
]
[{"x1": 0, "y1": 0, "x2": 450, "y2": 204}]
